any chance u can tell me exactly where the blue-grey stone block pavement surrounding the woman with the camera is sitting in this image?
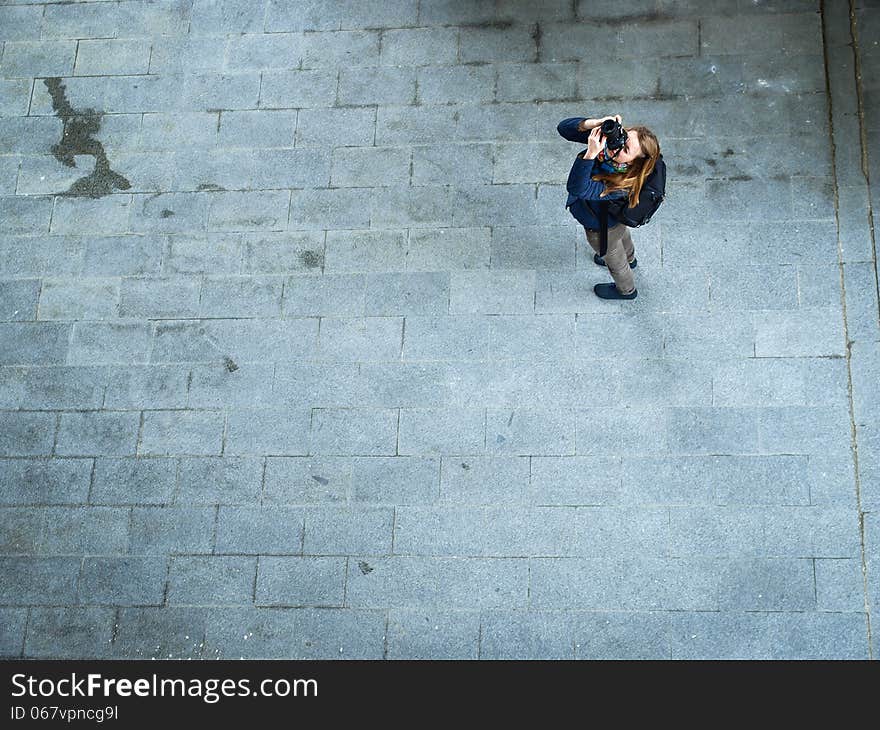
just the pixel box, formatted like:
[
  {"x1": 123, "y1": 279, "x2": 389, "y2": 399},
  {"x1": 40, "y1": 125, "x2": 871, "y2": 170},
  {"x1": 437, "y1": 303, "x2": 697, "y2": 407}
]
[{"x1": 0, "y1": 0, "x2": 880, "y2": 659}]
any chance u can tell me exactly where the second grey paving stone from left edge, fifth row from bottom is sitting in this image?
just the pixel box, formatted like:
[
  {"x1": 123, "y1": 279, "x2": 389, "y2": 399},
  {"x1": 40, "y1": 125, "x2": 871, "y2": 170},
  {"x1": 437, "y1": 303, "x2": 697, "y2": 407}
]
[{"x1": 55, "y1": 411, "x2": 140, "y2": 456}]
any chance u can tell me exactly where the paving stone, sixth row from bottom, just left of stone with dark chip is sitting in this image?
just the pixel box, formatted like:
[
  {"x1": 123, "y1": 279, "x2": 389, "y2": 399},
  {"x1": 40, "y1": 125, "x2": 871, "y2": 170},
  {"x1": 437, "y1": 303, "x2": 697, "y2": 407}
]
[{"x1": 105, "y1": 365, "x2": 189, "y2": 410}]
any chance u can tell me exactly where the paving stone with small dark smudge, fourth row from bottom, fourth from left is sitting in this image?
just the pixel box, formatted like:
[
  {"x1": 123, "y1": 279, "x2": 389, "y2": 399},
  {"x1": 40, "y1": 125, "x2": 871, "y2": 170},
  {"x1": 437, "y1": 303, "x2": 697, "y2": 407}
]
[{"x1": 263, "y1": 456, "x2": 351, "y2": 504}]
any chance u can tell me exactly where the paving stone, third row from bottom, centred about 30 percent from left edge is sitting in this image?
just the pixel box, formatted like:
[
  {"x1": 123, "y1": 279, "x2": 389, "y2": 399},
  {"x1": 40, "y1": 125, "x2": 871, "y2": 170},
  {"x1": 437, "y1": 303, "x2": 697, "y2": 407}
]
[{"x1": 217, "y1": 506, "x2": 303, "y2": 555}]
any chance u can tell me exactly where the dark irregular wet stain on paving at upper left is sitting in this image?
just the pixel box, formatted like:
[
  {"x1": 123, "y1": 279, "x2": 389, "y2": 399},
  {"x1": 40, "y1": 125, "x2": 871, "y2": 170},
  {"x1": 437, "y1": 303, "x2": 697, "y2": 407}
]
[{"x1": 43, "y1": 77, "x2": 131, "y2": 198}]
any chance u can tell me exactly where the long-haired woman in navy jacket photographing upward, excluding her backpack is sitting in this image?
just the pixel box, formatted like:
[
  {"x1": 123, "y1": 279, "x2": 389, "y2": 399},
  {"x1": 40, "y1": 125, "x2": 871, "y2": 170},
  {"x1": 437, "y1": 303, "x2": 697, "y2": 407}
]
[{"x1": 557, "y1": 115, "x2": 660, "y2": 299}]
